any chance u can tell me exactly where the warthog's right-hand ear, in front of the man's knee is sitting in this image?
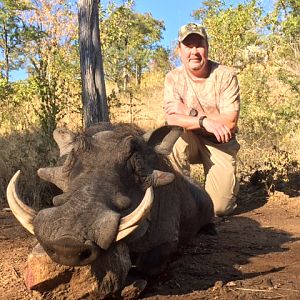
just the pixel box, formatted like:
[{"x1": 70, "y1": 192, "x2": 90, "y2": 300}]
[{"x1": 144, "y1": 125, "x2": 183, "y2": 155}]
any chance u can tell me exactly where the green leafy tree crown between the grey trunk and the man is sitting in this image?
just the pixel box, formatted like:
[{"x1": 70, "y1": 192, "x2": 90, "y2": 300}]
[{"x1": 100, "y1": 1, "x2": 164, "y2": 90}]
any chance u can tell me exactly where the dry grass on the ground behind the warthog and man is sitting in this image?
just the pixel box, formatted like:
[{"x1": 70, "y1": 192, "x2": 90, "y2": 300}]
[{"x1": 0, "y1": 69, "x2": 300, "y2": 206}]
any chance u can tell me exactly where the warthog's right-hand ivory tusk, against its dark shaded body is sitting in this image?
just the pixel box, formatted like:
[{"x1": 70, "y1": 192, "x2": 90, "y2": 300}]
[{"x1": 116, "y1": 186, "x2": 154, "y2": 241}]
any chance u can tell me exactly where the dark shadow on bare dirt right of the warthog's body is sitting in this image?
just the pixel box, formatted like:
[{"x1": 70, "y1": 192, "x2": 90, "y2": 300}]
[{"x1": 143, "y1": 216, "x2": 293, "y2": 297}]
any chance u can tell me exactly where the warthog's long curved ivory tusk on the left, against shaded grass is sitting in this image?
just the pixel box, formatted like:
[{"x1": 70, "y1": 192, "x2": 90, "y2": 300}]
[{"x1": 6, "y1": 170, "x2": 37, "y2": 235}]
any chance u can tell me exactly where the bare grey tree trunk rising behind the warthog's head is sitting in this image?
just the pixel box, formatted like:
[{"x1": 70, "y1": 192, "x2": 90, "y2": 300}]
[{"x1": 78, "y1": 0, "x2": 109, "y2": 127}]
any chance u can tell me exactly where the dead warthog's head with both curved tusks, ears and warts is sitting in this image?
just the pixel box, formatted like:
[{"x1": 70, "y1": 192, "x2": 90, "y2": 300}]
[{"x1": 7, "y1": 124, "x2": 182, "y2": 266}]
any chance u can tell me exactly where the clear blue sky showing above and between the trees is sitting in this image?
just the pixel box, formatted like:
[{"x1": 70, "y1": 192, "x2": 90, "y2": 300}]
[{"x1": 12, "y1": 0, "x2": 274, "y2": 80}]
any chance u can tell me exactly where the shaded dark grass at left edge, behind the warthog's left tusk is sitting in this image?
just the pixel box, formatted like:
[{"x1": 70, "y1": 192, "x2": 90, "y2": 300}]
[{"x1": 0, "y1": 130, "x2": 58, "y2": 207}]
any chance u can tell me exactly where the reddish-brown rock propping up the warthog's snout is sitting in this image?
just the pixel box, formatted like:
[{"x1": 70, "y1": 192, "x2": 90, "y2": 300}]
[{"x1": 24, "y1": 243, "x2": 131, "y2": 299}]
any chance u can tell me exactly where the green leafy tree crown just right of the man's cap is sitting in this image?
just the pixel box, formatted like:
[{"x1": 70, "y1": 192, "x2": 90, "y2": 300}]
[{"x1": 193, "y1": 0, "x2": 262, "y2": 68}]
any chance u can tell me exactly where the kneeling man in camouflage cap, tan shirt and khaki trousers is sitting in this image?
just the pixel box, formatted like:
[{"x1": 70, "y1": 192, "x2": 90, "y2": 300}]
[{"x1": 164, "y1": 23, "x2": 240, "y2": 216}]
